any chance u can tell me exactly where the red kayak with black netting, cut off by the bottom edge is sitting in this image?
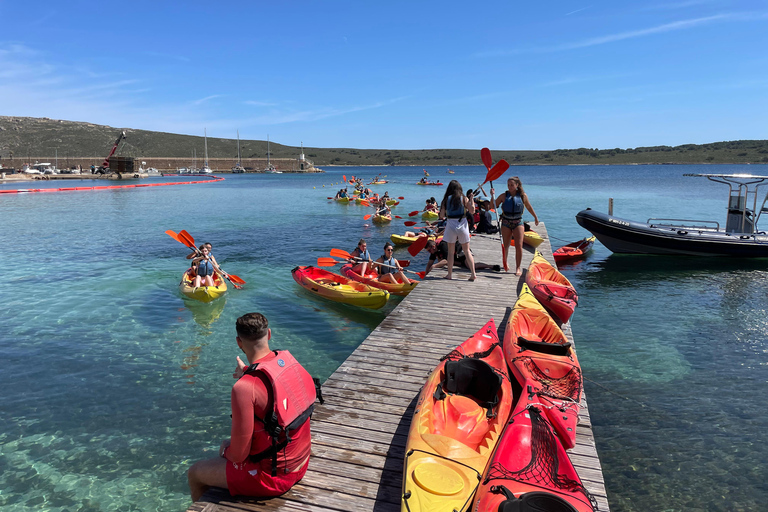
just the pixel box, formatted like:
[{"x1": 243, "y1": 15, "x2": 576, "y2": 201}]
[{"x1": 471, "y1": 396, "x2": 597, "y2": 512}]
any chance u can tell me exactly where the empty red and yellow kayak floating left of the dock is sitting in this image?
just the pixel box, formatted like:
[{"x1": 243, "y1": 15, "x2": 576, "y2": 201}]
[{"x1": 291, "y1": 266, "x2": 389, "y2": 309}]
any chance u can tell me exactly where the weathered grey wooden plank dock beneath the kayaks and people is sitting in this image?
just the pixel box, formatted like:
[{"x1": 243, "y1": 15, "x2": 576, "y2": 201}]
[{"x1": 189, "y1": 224, "x2": 609, "y2": 512}]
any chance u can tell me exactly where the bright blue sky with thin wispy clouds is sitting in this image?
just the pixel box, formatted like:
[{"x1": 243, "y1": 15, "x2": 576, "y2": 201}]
[{"x1": 0, "y1": 0, "x2": 768, "y2": 149}]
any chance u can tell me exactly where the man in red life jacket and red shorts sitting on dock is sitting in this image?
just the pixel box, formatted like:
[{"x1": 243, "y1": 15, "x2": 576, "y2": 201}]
[{"x1": 187, "y1": 313, "x2": 316, "y2": 501}]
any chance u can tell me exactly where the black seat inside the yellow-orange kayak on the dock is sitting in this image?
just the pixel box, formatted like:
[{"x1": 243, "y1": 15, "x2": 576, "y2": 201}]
[{"x1": 434, "y1": 357, "x2": 502, "y2": 417}]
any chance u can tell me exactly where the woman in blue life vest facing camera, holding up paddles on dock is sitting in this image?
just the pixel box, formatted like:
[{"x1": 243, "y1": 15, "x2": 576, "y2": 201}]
[{"x1": 491, "y1": 176, "x2": 539, "y2": 276}]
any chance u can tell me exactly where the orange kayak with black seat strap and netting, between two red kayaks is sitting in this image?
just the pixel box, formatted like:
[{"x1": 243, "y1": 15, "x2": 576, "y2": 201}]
[{"x1": 504, "y1": 284, "x2": 583, "y2": 450}]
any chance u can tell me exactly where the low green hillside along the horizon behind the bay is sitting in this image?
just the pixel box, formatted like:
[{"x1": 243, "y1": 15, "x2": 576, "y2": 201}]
[{"x1": 0, "y1": 116, "x2": 768, "y2": 167}]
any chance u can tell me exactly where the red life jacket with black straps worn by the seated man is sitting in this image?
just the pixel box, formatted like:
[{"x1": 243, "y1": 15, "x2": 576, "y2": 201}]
[{"x1": 243, "y1": 350, "x2": 323, "y2": 476}]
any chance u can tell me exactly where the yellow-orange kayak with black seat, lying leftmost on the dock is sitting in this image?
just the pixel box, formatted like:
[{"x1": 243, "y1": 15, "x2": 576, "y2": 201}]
[{"x1": 401, "y1": 319, "x2": 513, "y2": 512}]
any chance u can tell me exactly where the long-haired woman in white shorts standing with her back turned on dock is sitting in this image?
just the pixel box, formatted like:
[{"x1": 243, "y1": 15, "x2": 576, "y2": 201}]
[{"x1": 439, "y1": 180, "x2": 477, "y2": 281}]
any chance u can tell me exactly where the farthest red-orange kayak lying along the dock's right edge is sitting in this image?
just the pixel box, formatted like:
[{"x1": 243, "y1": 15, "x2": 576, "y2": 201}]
[{"x1": 525, "y1": 251, "x2": 579, "y2": 323}]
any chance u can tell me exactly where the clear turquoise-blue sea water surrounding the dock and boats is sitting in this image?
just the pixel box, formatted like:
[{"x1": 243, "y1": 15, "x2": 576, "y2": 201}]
[{"x1": 0, "y1": 165, "x2": 768, "y2": 512}]
